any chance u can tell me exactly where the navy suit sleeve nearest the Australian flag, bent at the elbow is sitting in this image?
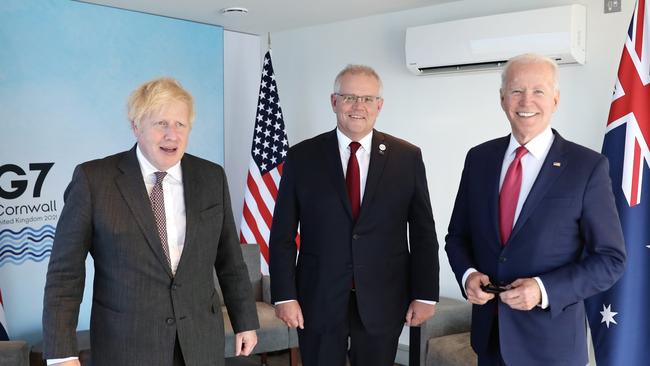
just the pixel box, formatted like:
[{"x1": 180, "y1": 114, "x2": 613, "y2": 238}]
[{"x1": 539, "y1": 157, "x2": 626, "y2": 316}]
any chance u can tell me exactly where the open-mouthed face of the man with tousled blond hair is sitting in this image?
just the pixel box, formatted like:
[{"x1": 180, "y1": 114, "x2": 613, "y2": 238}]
[{"x1": 131, "y1": 100, "x2": 190, "y2": 171}]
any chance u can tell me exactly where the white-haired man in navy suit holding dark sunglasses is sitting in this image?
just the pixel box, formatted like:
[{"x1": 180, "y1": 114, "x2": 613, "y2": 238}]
[{"x1": 445, "y1": 54, "x2": 625, "y2": 366}]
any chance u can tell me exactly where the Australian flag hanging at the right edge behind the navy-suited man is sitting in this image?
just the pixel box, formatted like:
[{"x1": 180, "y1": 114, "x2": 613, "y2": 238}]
[{"x1": 587, "y1": 0, "x2": 650, "y2": 366}]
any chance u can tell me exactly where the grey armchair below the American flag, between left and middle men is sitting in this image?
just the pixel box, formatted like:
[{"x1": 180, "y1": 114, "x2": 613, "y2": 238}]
[{"x1": 217, "y1": 244, "x2": 298, "y2": 366}]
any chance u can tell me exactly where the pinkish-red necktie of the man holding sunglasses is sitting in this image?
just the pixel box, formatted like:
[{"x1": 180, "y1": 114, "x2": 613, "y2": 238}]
[{"x1": 499, "y1": 146, "x2": 528, "y2": 245}]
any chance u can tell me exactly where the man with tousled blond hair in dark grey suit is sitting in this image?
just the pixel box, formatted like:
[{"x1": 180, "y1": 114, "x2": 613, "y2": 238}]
[{"x1": 43, "y1": 78, "x2": 258, "y2": 366}]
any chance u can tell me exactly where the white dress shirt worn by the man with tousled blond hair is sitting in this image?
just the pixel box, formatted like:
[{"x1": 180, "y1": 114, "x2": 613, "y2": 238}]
[{"x1": 47, "y1": 146, "x2": 185, "y2": 365}]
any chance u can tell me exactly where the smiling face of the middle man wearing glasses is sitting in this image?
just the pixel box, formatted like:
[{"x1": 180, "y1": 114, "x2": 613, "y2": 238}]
[{"x1": 331, "y1": 73, "x2": 384, "y2": 141}]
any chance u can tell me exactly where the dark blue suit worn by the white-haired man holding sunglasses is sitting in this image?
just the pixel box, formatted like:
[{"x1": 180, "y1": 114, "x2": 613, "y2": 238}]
[{"x1": 445, "y1": 131, "x2": 625, "y2": 366}]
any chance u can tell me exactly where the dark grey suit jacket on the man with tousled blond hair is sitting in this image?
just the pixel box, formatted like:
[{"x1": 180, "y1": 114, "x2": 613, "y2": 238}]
[{"x1": 43, "y1": 147, "x2": 258, "y2": 366}]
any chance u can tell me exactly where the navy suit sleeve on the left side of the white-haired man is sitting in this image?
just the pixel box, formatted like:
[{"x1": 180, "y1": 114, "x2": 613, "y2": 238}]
[{"x1": 445, "y1": 150, "x2": 476, "y2": 297}]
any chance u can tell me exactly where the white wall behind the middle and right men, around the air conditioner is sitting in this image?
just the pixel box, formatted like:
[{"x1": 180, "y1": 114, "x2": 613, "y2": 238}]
[{"x1": 256, "y1": 0, "x2": 633, "y2": 298}]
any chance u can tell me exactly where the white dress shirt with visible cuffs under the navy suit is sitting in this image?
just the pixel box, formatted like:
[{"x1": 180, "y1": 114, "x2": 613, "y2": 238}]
[{"x1": 462, "y1": 126, "x2": 555, "y2": 309}]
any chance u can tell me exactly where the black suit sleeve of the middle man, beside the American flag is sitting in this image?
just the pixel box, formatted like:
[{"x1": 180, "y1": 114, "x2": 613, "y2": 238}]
[{"x1": 269, "y1": 150, "x2": 300, "y2": 303}]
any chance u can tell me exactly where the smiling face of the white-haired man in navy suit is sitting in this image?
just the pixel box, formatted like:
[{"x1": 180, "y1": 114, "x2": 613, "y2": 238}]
[{"x1": 500, "y1": 62, "x2": 560, "y2": 145}]
